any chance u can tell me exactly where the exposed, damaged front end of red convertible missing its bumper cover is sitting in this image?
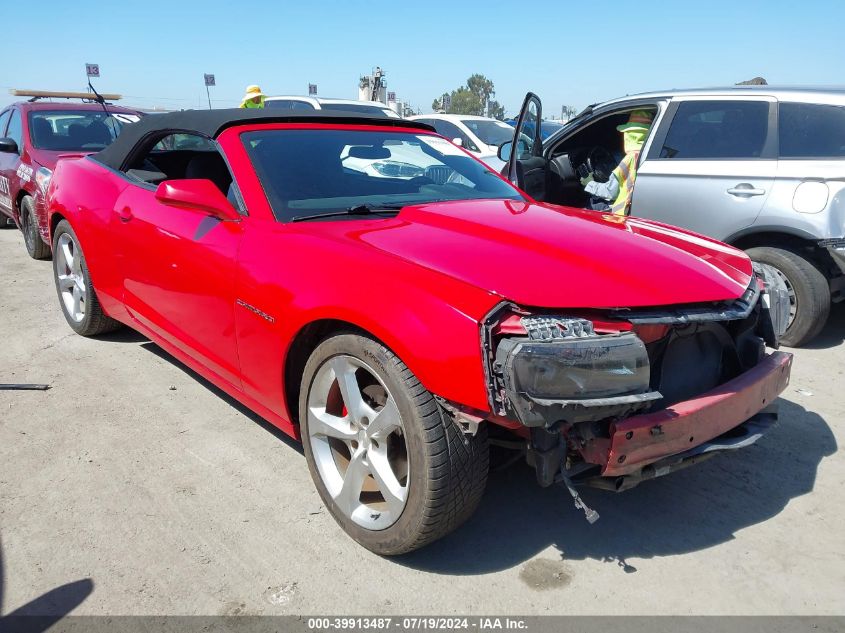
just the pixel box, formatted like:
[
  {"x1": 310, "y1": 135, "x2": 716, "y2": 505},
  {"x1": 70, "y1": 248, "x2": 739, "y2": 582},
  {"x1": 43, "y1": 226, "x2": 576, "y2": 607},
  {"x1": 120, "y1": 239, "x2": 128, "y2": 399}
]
[{"x1": 482, "y1": 276, "x2": 792, "y2": 494}]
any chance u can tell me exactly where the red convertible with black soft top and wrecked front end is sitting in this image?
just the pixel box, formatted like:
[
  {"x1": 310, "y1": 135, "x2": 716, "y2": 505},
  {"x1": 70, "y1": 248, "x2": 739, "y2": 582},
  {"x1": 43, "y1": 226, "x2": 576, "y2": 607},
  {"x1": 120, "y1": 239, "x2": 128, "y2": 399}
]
[{"x1": 48, "y1": 110, "x2": 791, "y2": 554}]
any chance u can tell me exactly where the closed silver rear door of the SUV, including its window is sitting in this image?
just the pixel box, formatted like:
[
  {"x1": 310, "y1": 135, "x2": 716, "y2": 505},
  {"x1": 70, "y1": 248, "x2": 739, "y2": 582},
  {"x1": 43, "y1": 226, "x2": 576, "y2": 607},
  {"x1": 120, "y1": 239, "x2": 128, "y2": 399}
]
[{"x1": 631, "y1": 96, "x2": 777, "y2": 239}]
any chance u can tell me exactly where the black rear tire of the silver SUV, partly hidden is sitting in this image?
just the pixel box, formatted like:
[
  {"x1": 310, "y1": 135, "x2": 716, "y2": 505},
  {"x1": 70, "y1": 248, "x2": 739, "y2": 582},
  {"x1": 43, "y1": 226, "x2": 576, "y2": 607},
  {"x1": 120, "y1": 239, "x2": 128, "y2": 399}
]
[{"x1": 746, "y1": 246, "x2": 830, "y2": 347}]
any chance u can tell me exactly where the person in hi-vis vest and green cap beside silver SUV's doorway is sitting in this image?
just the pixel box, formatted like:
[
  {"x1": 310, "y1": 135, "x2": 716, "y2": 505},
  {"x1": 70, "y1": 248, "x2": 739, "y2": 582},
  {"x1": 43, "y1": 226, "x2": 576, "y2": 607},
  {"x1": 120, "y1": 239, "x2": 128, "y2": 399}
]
[{"x1": 581, "y1": 110, "x2": 654, "y2": 215}]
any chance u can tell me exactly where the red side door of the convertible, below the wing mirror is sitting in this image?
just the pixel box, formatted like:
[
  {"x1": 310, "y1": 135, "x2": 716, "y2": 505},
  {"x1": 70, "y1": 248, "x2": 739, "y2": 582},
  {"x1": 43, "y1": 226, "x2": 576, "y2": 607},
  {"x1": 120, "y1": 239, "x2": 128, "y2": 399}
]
[{"x1": 111, "y1": 139, "x2": 243, "y2": 388}]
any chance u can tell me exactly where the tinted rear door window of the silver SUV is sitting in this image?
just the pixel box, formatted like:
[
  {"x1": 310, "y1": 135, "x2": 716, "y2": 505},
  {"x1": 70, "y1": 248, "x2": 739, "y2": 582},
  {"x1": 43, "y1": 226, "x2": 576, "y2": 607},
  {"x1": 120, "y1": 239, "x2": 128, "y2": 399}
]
[{"x1": 658, "y1": 101, "x2": 769, "y2": 159}]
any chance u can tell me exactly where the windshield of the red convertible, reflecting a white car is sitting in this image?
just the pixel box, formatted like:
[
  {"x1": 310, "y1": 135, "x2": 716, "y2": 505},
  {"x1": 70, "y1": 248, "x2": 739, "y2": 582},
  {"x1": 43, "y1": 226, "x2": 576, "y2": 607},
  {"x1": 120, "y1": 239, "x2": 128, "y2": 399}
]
[{"x1": 241, "y1": 129, "x2": 523, "y2": 222}]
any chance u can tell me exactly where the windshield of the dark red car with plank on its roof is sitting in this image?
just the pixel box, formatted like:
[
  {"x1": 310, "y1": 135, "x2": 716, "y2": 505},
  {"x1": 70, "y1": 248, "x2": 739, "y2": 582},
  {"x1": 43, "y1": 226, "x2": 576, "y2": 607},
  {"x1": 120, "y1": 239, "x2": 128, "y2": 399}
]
[{"x1": 29, "y1": 110, "x2": 140, "y2": 152}]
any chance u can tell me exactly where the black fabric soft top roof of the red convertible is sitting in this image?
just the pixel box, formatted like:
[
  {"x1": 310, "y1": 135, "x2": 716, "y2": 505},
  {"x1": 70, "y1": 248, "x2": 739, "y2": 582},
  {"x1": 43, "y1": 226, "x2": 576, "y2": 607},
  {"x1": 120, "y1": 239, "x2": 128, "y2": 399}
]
[{"x1": 91, "y1": 108, "x2": 434, "y2": 169}]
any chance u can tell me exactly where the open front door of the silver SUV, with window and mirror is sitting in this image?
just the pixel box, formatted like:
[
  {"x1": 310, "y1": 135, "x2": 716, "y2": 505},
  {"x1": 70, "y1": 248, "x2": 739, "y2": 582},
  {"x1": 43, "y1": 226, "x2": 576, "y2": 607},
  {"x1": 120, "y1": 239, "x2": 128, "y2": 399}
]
[{"x1": 499, "y1": 92, "x2": 547, "y2": 200}]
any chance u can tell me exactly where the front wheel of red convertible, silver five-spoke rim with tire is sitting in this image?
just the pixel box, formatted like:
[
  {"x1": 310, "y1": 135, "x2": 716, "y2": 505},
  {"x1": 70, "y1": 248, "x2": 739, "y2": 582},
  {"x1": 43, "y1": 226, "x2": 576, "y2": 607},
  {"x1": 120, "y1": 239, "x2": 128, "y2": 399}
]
[{"x1": 299, "y1": 334, "x2": 489, "y2": 555}]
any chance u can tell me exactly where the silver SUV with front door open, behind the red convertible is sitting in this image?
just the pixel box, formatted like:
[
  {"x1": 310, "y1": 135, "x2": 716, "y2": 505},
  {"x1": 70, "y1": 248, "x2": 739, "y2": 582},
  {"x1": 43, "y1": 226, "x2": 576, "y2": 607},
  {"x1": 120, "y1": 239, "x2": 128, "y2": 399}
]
[{"x1": 499, "y1": 86, "x2": 845, "y2": 346}]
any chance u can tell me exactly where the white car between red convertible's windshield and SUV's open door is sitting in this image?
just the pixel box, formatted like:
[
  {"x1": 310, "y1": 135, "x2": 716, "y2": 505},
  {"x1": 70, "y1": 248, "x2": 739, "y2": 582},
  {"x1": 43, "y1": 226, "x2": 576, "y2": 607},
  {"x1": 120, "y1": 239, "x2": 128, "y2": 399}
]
[{"x1": 409, "y1": 114, "x2": 513, "y2": 172}]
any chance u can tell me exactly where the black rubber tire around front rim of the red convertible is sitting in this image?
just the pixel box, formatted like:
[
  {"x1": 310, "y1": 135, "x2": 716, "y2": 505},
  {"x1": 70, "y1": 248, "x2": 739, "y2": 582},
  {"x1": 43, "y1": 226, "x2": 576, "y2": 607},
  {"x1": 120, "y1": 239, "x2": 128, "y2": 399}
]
[{"x1": 299, "y1": 333, "x2": 489, "y2": 556}]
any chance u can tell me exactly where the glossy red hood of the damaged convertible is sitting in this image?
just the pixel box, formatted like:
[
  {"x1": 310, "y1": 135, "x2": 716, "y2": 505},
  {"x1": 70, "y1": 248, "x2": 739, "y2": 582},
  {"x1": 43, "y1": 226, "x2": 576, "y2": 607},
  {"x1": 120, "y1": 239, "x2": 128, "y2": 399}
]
[{"x1": 352, "y1": 200, "x2": 752, "y2": 308}]
